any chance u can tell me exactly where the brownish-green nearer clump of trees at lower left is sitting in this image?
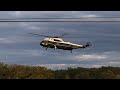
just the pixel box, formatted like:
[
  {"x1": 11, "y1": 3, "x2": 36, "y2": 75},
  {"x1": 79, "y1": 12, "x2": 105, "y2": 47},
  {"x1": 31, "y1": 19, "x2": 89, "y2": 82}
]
[{"x1": 0, "y1": 63, "x2": 55, "y2": 79}]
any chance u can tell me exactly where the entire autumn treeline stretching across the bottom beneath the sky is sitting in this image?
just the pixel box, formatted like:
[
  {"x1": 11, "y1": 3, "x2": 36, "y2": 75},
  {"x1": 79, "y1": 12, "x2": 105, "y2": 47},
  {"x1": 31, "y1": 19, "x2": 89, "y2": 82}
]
[{"x1": 0, "y1": 63, "x2": 120, "y2": 79}]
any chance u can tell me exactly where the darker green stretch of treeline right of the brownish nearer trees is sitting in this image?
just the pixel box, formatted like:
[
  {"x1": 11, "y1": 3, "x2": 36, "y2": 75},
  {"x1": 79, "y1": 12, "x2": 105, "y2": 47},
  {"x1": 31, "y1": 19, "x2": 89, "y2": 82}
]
[{"x1": 54, "y1": 66, "x2": 120, "y2": 79}]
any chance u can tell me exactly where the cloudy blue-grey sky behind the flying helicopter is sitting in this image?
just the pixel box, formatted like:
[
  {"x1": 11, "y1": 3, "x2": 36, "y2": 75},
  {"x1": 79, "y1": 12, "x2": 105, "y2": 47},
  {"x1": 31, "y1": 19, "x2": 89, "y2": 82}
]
[{"x1": 0, "y1": 11, "x2": 120, "y2": 70}]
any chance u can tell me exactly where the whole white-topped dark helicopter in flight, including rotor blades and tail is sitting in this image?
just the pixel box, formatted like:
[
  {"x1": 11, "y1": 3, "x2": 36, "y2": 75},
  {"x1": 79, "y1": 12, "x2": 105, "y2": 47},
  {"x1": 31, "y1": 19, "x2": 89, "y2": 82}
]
[{"x1": 29, "y1": 33, "x2": 92, "y2": 53}]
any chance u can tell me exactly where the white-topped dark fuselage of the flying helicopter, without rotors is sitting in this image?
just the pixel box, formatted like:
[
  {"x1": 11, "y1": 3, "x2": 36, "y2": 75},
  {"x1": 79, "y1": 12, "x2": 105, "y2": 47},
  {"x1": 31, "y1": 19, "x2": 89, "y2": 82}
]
[{"x1": 40, "y1": 38, "x2": 88, "y2": 51}]
